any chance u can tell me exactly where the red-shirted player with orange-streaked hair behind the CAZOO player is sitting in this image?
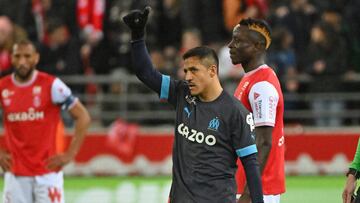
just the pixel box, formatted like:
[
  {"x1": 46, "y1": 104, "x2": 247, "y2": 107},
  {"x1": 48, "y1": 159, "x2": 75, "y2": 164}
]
[{"x1": 229, "y1": 19, "x2": 285, "y2": 203}]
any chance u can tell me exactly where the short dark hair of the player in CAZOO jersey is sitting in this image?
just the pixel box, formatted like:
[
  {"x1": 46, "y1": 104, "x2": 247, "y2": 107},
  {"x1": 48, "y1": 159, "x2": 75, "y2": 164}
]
[{"x1": 183, "y1": 46, "x2": 219, "y2": 73}]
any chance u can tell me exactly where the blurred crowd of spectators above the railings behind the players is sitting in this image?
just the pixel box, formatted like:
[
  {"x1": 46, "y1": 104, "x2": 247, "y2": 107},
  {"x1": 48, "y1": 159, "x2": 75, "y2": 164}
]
[{"x1": 0, "y1": 0, "x2": 360, "y2": 126}]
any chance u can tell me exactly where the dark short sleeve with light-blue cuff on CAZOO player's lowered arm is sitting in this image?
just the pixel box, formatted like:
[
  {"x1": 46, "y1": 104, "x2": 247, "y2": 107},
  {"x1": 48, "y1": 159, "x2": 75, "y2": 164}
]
[{"x1": 232, "y1": 107, "x2": 257, "y2": 158}]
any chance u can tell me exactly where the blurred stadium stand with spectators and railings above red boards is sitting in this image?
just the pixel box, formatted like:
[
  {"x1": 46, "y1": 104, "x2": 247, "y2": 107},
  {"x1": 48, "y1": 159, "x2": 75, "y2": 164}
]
[{"x1": 0, "y1": 0, "x2": 360, "y2": 130}]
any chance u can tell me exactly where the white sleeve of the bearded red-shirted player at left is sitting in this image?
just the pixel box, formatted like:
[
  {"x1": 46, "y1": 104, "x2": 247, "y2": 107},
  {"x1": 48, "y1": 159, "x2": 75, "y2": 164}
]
[{"x1": 51, "y1": 78, "x2": 77, "y2": 110}]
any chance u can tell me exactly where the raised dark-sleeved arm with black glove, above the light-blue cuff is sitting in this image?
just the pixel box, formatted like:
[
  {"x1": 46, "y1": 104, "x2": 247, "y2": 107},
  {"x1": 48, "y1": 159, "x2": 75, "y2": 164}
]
[{"x1": 123, "y1": 7, "x2": 166, "y2": 94}]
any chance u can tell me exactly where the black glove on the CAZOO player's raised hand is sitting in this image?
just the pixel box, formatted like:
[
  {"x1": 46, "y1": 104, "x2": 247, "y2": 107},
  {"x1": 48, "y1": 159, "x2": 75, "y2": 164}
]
[{"x1": 123, "y1": 6, "x2": 151, "y2": 40}]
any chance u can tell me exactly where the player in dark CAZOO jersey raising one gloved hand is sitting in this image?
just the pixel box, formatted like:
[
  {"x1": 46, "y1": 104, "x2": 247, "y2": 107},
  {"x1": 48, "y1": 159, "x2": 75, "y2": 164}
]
[{"x1": 124, "y1": 7, "x2": 263, "y2": 203}]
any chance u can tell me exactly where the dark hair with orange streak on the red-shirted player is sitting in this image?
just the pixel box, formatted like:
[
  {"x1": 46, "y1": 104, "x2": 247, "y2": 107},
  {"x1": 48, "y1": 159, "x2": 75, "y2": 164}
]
[{"x1": 239, "y1": 18, "x2": 271, "y2": 49}]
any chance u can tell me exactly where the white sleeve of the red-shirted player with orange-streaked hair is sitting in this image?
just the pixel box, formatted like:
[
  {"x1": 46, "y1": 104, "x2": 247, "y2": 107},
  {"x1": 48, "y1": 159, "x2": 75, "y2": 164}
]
[{"x1": 248, "y1": 81, "x2": 279, "y2": 127}]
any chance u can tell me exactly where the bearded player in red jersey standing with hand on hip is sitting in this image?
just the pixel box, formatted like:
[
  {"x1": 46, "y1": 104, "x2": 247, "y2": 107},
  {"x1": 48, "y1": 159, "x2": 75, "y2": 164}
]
[{"x1": 0, "y1": 40, "x2": 90, "y2": 203}]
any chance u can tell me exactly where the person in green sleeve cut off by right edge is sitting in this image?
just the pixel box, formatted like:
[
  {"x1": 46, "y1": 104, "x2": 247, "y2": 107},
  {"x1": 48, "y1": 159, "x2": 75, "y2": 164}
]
[{"x1": 342, "y1": 139, "x2": 360, "y2": 203}]
